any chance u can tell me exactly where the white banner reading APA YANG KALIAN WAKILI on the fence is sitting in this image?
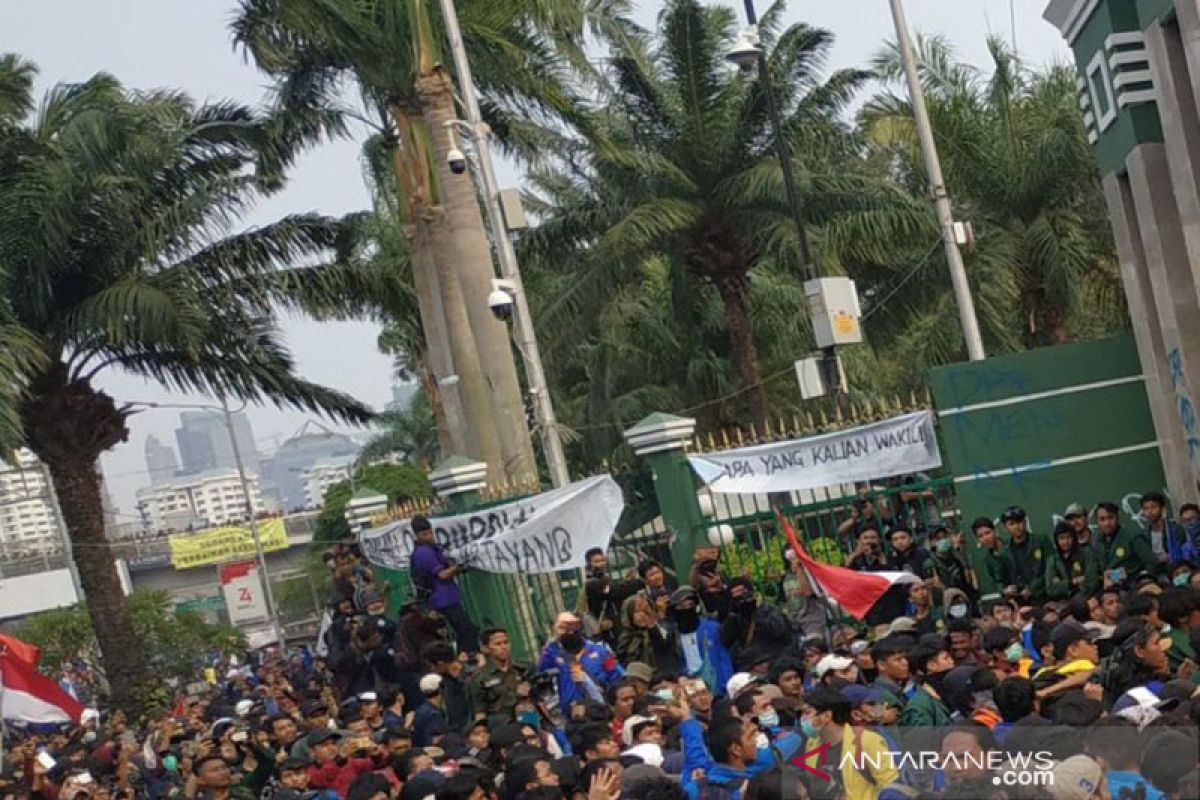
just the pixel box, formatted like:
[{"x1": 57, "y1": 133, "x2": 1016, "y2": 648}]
[{"x1": 688, "y1": 410, "x2": 942, "y2": 494}]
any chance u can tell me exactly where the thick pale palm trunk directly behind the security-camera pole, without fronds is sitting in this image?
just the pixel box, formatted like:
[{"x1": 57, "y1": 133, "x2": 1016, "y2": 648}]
[{"x1": 418, "y1": 67, "x2": 538, "y2": 482}]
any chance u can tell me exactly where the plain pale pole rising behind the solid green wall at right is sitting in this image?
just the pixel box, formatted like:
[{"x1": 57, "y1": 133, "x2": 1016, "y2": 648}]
[{"x1": 883, "y1": 0, "x2": 986, "y2": 361}]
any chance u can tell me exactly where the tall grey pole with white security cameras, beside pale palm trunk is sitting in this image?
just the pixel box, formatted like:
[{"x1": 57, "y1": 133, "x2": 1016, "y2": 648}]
[{"x1": 439, "y1": 0, "x2": 571, "y2": 487}]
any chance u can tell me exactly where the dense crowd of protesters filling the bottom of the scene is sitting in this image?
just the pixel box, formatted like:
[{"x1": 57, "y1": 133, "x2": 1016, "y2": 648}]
[{"x1": 0, "y1": 494, "x2": 1200, "y2": 800}]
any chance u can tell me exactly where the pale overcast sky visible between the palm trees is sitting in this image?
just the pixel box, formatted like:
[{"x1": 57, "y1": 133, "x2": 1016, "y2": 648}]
[{"x1": 0, "y1": 0, "x2": 1069, "y2": 519}]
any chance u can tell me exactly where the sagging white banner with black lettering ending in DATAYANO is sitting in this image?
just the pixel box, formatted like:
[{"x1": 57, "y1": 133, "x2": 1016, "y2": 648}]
[{"x1": 359, "y1": 476, "x2": 625, "y2": 573}]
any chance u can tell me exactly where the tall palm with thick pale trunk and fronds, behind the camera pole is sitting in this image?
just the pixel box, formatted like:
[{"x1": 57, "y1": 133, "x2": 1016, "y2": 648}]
[{"x1": 234, "y1": 0, "x2": 622, "y2": 479}]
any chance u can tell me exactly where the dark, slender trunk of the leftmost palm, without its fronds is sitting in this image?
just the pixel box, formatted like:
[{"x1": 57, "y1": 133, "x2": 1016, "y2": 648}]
[{"x1": 22, "y1": 365, "x2": 150, "y2": 716}]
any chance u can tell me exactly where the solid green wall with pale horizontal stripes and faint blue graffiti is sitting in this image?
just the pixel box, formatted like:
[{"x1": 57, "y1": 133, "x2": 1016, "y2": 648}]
[{"x1": 930, "y1": 335, "x2": 1165, "y2": 533}]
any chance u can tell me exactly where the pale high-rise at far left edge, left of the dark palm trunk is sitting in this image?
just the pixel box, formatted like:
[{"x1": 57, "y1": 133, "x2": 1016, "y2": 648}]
[{"x1": 0, "y1": 449, "x2": 64, "y2": 561}]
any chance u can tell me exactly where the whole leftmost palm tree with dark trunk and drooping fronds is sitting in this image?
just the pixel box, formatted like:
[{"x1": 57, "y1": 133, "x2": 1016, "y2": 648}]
[{"x1": 0, "y1": 58, "x2": 370, "y2": 711}]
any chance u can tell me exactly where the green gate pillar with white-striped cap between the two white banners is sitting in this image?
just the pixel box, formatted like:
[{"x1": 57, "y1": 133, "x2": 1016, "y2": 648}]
[{"x1": 625, "y1": 414, "x2": 708, "y2": 583}]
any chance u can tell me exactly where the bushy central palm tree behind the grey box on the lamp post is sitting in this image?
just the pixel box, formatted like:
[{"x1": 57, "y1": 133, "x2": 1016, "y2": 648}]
[{"x1": 527, "y1": 0, "x2": 895, "y2": 426}]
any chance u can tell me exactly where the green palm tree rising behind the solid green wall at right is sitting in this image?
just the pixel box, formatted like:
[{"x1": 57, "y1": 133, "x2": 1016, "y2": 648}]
[{"x1": 856, "y1": 38, "x2": 1127, "y2": 371}]
